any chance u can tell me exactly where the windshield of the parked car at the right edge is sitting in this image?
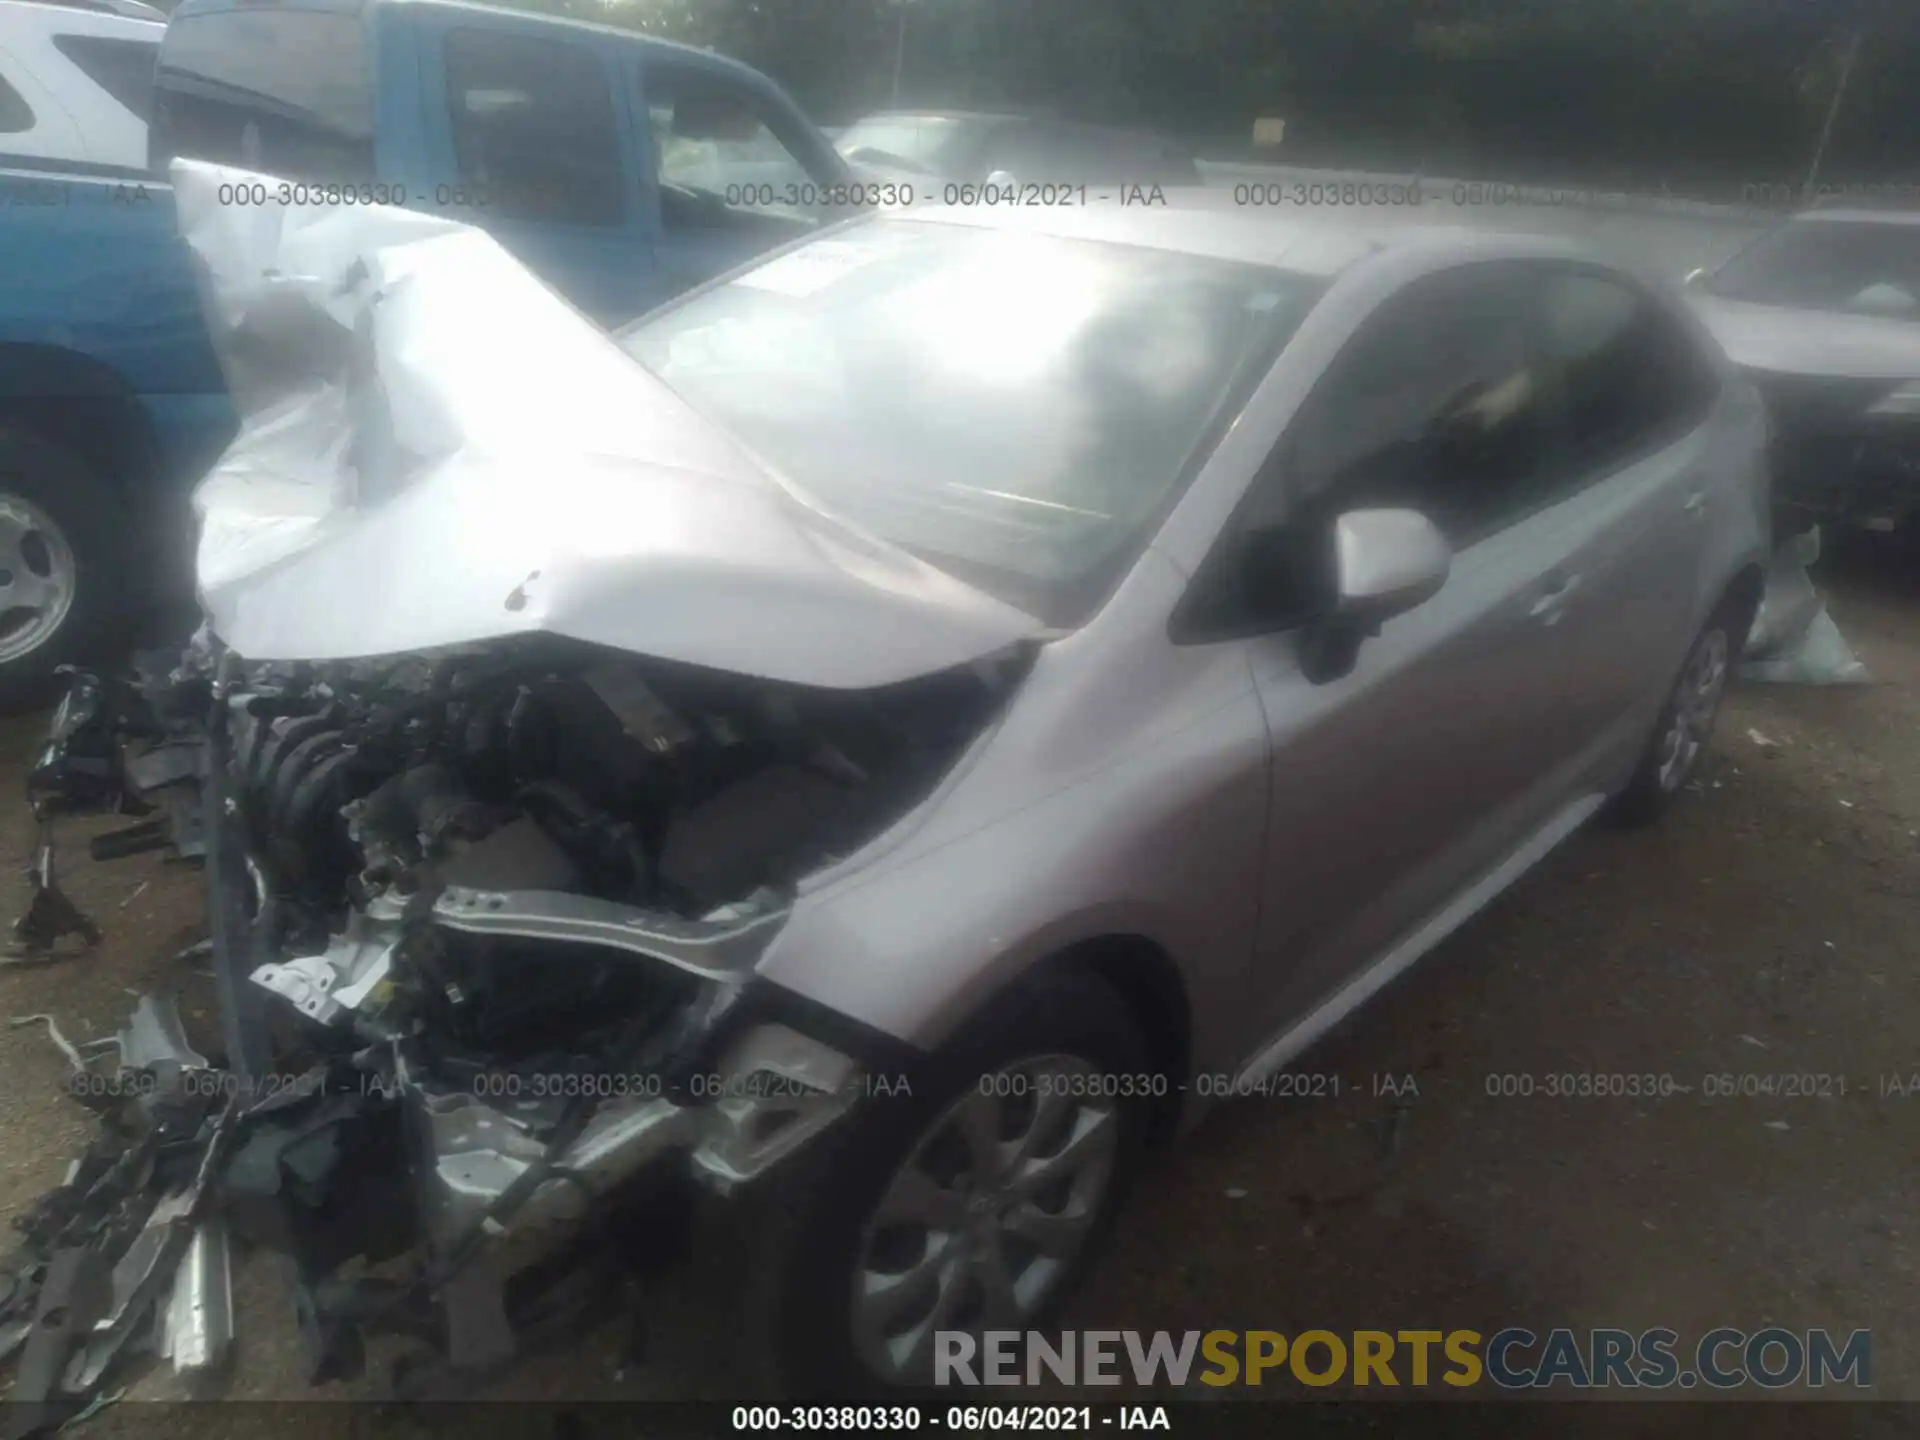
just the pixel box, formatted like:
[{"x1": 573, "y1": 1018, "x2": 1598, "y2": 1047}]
[{"x1": 1707, "y1": 219, "x2": 1920, "y2": 321}]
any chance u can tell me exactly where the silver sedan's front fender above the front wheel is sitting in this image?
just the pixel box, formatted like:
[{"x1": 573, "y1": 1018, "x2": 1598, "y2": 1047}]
[{"x1": 760, "y1": 691, "x2": 1267, "y2": 1064}]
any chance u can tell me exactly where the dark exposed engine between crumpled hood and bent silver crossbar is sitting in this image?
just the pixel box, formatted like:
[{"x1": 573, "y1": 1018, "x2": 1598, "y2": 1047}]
[{"x1": 232, "y1": 641, "x2": 995, "y2": 929}]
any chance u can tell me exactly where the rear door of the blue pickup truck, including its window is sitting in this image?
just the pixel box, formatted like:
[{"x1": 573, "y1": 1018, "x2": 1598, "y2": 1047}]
[{"x1": 415, "y1": 10, "x2": 655, "y2": 326}]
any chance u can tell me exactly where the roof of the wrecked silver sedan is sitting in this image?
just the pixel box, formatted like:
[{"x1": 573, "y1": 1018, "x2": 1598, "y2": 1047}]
[{"x1": 887, "y1": 201, "x2": 1607, "y2": 280}]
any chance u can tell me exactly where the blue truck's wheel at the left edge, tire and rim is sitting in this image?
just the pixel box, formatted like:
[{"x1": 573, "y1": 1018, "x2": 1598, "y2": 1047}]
[{"x1": 0, "y1": 426, "x2": 125, "y2": 714}]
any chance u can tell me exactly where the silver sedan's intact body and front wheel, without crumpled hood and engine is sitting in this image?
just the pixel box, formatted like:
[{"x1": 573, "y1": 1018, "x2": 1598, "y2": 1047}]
[{"x1": 622, "y1": 205, "x2": 1766, "y2": 1390}]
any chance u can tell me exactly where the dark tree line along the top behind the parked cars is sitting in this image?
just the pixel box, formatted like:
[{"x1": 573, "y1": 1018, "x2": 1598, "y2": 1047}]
[{"x1": 149, "y1": 0, "x2": 1920, "y2": 198}]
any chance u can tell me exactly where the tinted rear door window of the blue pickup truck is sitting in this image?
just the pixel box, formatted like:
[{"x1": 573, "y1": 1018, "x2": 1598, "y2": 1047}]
[{"x1": 447, "y1": 29, "x2": 626, "y2": 225}]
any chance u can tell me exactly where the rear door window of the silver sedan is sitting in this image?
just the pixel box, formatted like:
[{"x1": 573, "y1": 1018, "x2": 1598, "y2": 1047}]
[{"x1": 1540, "y1": 271, "x2": 1716, "y2": 470}]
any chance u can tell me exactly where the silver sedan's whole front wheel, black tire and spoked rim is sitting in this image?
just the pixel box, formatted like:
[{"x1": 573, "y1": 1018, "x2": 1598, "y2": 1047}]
[{"x1": 760, "y1": 973, "x2": 1158, "y2": 1396}]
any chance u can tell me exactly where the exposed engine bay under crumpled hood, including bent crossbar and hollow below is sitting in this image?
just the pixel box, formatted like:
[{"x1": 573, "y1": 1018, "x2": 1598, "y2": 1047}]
[{"x1": 228, "y1": 641, "x2": 1000, "y2": 1060}]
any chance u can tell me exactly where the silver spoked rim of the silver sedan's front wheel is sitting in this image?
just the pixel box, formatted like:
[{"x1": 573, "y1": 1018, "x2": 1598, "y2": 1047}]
[{"x1": 852, "y1": 1054, "x2": 1121, "y2": 1384}]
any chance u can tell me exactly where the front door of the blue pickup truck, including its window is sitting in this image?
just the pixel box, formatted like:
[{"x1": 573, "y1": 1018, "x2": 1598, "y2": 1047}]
[{"x1": 628, "y1": 56, "x2": 851, "y2": 312}]
